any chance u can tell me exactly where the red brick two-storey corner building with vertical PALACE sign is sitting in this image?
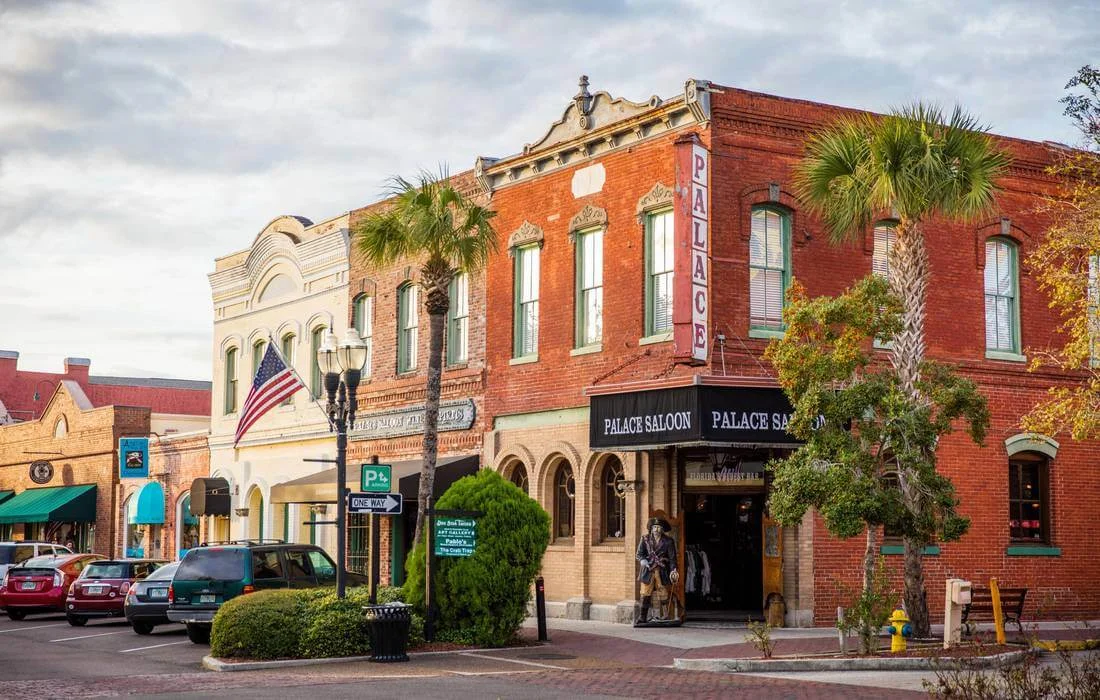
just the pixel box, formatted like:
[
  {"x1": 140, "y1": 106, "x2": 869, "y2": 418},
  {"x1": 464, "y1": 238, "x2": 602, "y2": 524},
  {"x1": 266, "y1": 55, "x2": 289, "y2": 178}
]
[{"x1": 475, "y1": 80, "x2": 1100, "y2": 625}]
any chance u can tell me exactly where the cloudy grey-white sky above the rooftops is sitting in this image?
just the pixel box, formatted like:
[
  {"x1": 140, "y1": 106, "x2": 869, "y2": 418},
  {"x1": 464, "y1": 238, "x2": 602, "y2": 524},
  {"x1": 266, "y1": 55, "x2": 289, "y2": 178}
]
[{"x1": 0, "y1": 0, "x2": 1100, "y2": 379}]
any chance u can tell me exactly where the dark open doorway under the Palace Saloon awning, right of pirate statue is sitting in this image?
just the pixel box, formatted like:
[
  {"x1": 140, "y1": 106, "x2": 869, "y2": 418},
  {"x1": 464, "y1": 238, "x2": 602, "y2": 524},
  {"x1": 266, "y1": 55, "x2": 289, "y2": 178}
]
[{"x1": 682, "y1": 492, "x2": 766, "y2": 621}]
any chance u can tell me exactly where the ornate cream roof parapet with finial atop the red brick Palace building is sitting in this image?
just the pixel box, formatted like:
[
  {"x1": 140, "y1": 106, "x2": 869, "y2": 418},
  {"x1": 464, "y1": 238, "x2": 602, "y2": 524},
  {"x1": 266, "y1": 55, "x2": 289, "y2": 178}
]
[{"x1": 474, "y1": 76, "x2": 711, "y2": 192}]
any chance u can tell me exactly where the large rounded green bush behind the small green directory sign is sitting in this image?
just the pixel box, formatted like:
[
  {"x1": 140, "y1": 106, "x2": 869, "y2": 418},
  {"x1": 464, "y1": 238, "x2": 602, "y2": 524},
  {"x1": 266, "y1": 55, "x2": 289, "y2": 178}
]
[{"x1": 404, "y1": 469, "x2": 550, "y2": 646}]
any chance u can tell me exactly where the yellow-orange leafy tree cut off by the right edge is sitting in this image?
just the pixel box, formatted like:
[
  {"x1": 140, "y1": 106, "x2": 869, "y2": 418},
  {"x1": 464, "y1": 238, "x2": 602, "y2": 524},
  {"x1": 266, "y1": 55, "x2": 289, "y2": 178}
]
[{"x1": 1023, "y1": 66, "x2": 1100, "y2": 440}]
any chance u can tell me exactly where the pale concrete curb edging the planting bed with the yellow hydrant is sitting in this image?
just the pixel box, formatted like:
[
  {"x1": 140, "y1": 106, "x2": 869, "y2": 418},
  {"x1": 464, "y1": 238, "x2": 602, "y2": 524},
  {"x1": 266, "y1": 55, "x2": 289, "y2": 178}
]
[{"x1": 673, "y1": 649, "x2": 1031, "y2": 674}]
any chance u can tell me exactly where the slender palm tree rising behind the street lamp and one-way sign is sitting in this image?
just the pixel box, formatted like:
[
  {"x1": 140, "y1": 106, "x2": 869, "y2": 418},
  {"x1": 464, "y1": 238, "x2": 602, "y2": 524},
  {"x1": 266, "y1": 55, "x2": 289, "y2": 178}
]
[{"x1": 353, "y1": 169, "x2": 497, "y2": 544}]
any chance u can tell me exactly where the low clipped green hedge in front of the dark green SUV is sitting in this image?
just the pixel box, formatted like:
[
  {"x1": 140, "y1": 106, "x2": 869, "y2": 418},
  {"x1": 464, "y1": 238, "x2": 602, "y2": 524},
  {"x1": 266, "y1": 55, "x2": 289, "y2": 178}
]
[{"x1": 210, "y1": 587, "x2": 424, "y2": 659}]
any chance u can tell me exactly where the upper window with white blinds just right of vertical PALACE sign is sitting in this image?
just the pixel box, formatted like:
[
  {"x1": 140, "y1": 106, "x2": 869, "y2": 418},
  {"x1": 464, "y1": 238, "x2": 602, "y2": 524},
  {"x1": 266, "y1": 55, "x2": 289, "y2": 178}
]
[{"x1": 749, "y1": 207, "x2": 791, "y2": 330}]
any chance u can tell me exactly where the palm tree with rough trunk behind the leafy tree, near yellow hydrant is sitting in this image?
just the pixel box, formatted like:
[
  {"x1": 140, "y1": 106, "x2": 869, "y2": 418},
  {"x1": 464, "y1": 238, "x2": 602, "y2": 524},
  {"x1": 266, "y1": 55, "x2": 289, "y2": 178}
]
[{"x1": 794, "y1": 103, "x2": 1009, "y2": 636}]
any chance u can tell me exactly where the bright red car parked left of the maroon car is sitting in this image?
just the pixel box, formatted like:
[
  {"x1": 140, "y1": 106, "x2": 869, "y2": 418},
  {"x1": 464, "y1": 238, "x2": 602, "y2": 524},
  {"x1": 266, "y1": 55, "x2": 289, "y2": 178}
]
[{"x1": 0, "y1": 554, "x2": 105, "y2": 620}]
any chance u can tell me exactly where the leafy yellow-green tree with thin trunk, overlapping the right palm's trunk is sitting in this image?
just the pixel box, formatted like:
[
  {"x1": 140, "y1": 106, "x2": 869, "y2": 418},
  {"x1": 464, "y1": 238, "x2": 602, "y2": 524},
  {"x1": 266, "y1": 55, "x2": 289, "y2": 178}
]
[{"x1": 766, "y1": 275, "x2": 989, "y2": 650}]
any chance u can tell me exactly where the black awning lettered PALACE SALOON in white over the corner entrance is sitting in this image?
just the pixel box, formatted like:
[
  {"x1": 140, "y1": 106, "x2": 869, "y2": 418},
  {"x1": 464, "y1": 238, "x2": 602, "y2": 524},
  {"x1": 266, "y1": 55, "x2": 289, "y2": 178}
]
[{"x1": 589, "y1": 385, "x2": 814, "y2": 448}]
